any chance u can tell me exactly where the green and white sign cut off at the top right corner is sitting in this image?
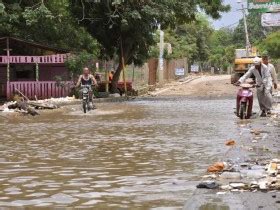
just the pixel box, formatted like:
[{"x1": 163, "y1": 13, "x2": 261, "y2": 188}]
[{"x1": 248, "y1": 0, "x2": 280, "y2": 12}]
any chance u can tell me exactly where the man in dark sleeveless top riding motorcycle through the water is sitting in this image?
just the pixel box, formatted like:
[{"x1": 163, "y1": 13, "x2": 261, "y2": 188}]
[{"x1": 76, "y1": 67, "x2": 97, "y2": 108}]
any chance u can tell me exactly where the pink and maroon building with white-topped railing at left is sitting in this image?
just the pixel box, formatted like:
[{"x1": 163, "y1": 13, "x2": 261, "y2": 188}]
[{"x1": 0, "y1": 37, "x2": 70, "y2": 99}]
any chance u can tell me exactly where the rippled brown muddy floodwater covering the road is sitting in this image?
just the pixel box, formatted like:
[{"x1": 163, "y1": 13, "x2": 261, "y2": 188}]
[{"x1": 0, "y1": 97, "x2": 241, "y2": 209}]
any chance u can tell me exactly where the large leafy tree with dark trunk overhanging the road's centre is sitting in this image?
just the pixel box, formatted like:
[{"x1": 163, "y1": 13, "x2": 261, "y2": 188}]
[{"x1": 70, "y1": 0, "x2": 229, "y2": 91}]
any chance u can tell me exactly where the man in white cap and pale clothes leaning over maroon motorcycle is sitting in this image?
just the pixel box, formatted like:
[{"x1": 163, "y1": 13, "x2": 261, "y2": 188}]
[{"x1": 236, "y1": 57, "x2": 272, "y2": 117}]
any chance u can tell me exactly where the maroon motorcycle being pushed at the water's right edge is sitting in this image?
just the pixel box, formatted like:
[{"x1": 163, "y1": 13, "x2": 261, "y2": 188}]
[{"x1": 236, "y1": 84, "x2": 255, "y2": 119}]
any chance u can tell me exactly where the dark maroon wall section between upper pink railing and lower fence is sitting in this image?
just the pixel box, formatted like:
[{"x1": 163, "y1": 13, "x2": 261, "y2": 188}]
[{"x1": 39, "y1": 64, "x2": 70, "y2": 81}]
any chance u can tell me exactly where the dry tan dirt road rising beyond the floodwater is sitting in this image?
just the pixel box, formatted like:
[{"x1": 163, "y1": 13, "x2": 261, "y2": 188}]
[{"x1": 157, "y1": 75, "x2": 237, "y2": 98}]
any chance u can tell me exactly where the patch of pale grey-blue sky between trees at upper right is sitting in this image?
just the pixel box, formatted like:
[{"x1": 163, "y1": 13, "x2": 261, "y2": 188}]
[{"x1": 213, "y1": 0, "x2": 246, "y2": 29}]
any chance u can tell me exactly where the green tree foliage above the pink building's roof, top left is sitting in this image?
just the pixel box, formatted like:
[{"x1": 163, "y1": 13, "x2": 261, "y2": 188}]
[{"x1": 0, "y1": 0, "x2": 99, "y2": 56}]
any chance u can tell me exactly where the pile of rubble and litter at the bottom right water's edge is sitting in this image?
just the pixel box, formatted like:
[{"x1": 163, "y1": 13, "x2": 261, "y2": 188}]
[{"x1": 197, "y1": 159, "x2": 280, "y2": 193}]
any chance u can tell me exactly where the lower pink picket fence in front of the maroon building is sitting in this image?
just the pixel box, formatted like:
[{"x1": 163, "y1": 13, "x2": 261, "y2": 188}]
[{"x1": 7, "y1": 81, "x2": 72, "y2": 99}]
